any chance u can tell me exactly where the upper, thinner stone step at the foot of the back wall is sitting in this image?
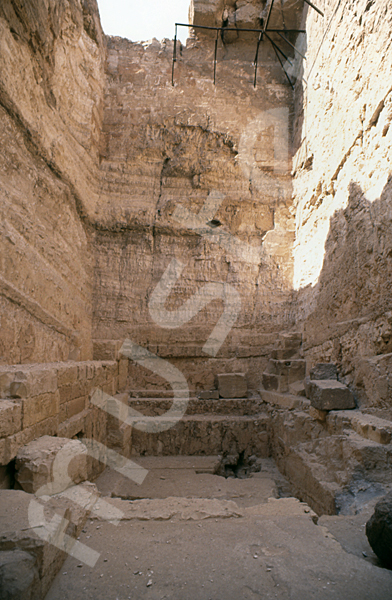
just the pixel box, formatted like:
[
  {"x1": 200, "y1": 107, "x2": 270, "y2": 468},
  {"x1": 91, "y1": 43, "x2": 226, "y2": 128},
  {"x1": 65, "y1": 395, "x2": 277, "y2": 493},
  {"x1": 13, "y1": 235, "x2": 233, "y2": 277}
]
[{"x1": 128, "y1": 397, "x2": 261, "y2": 416}]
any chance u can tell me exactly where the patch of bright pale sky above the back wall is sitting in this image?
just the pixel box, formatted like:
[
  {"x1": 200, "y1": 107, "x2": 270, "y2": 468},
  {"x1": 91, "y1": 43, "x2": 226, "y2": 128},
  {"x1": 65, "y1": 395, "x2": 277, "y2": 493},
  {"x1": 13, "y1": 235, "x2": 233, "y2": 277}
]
[{"x1": 98, "y1": 0, "x2": 190, "y2": 42}]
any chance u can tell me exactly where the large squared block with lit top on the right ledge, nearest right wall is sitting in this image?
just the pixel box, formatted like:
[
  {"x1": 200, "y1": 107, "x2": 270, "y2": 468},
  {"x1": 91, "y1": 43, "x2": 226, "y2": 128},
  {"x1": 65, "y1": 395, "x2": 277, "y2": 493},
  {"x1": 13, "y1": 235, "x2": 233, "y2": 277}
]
[{"x1": 307, "y1": 379, "x2": 355, "y2": 410}]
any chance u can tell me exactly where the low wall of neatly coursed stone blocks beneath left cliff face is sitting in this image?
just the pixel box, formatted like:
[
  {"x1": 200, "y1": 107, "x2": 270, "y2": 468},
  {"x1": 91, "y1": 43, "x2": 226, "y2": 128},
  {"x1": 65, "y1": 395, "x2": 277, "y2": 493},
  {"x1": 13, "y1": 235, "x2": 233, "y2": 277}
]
[{"x1": 0, "y1": 361, "x2": 126, "y2": 473}]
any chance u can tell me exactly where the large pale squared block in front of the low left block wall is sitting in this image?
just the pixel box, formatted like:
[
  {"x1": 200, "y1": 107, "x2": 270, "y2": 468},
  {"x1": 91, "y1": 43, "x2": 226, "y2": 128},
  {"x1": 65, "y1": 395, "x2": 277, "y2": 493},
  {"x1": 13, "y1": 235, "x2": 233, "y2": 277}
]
[{"x1": 15, "y1": 435, "x2": 88, "y2": 495}]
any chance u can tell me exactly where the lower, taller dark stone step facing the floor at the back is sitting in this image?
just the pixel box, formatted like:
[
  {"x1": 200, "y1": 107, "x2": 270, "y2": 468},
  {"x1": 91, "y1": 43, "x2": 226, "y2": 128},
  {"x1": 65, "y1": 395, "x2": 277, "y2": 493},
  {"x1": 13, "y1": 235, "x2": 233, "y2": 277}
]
[{"x1": 132, "y1": 413, "x2": 269, "y2": 458}]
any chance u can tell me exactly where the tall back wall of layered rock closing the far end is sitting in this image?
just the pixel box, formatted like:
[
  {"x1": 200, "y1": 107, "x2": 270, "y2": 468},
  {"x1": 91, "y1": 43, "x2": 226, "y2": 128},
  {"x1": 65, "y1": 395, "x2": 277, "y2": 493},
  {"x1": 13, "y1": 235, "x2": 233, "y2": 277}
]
[{"x1": 94, "y1": 22, "x2": 294, "y2": 388}]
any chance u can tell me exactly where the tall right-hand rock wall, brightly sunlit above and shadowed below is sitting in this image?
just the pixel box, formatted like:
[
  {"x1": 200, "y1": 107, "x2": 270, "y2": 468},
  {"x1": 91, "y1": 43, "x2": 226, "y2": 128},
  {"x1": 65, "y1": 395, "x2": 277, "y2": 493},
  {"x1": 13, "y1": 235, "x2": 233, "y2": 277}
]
[{"x1": 293, "y1": 0, "x2": 392, "y2": 409}]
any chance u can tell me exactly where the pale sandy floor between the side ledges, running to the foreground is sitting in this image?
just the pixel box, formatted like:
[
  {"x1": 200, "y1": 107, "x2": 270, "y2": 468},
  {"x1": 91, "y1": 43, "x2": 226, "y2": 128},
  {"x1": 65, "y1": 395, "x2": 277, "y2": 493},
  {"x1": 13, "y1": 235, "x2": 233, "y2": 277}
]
[{"x1": 46, "y1": 458, "x2": 392, "y2": 600}]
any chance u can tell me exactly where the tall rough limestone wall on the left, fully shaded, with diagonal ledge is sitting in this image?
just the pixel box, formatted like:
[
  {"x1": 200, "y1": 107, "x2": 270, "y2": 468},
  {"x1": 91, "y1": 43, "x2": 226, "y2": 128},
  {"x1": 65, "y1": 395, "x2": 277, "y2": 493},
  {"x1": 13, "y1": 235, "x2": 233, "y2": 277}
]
[{"x1": 0, "y1": 0, "x2": 105, "y2": 363}]
